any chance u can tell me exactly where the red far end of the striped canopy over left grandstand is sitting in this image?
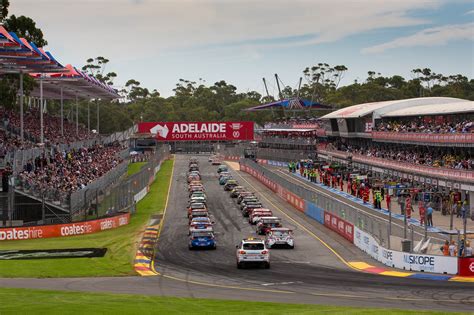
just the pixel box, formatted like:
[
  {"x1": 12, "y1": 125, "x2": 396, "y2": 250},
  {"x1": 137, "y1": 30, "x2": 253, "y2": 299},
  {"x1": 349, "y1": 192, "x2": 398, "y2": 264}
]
[{"x1": 31, "y1": 65, "x2": 120, "y2": 99}]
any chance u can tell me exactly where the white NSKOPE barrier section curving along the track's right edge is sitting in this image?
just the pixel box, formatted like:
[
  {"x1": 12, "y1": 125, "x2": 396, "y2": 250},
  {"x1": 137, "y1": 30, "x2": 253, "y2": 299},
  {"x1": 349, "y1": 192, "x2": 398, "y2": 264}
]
[{"x1": 354, "y1": 227, "x2": 458, "y2": 275}]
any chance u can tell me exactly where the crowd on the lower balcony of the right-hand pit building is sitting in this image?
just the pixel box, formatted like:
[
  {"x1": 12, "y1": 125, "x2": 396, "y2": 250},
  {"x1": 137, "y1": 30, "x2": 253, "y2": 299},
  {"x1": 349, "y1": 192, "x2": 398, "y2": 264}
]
[{"x1": 327, "y1": 141, "x2": 474, "y2": 170}]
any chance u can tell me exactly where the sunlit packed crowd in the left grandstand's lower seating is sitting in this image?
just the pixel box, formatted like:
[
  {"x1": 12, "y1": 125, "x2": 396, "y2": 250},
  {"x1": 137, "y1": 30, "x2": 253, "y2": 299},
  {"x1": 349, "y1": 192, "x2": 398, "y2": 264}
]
[{"x1": 18, "y1": 143, "x2": 124, "y2": 198}]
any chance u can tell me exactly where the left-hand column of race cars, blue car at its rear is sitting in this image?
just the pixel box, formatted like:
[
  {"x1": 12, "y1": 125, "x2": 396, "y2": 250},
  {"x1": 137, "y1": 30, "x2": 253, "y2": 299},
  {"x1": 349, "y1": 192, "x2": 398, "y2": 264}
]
[{"x1": 187, "y1": 158, "x2": 217, "y2": 250}]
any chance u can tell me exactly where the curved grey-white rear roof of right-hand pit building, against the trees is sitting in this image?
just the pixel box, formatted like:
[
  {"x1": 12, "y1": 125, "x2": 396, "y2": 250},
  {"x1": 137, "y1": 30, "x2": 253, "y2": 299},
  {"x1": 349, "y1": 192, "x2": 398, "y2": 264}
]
[{"x1": 321, "y1": 97, "x2": 465, "y2": 119}]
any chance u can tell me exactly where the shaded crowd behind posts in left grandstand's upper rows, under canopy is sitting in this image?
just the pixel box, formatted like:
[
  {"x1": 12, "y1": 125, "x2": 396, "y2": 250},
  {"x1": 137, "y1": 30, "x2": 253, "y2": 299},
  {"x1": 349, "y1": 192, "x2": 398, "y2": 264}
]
[{"x1": 0, "y1": 107, "x2": 97, "y2": 144}]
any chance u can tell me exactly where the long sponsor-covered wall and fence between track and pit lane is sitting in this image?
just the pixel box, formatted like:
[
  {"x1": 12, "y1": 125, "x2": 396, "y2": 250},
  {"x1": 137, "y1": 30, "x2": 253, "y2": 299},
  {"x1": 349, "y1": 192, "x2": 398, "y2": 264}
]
[{"x1": 240, "y1": 159, "x2": 458, "y2": 274}]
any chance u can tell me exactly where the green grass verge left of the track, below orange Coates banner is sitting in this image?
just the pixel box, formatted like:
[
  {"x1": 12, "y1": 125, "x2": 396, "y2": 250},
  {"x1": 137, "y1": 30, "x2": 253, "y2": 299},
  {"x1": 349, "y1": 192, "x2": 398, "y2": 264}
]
[{"x1": 0, "y1": 160, "x2": 173, "y2": 278}]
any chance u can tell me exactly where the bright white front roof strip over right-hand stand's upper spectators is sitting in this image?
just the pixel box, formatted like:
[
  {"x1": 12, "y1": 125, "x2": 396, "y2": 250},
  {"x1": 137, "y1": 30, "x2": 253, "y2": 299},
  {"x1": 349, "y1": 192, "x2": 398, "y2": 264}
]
[{"x1": 381, "y1": 101, "x2": 474, "y2": 118}]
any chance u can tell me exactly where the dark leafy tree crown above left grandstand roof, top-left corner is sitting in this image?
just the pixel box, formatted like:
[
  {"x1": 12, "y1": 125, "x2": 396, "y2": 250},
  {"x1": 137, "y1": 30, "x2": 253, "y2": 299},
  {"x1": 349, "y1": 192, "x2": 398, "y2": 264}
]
[{"x1": 3, "y1": 15, "x2": 48, "y2": 47}]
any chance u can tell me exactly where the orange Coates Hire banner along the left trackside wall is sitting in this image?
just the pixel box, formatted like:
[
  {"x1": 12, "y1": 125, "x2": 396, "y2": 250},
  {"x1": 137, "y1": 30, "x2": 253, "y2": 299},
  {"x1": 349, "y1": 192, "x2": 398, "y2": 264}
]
[{"x1": 0, "y1": 213, "x2": 130, "y2": 241}]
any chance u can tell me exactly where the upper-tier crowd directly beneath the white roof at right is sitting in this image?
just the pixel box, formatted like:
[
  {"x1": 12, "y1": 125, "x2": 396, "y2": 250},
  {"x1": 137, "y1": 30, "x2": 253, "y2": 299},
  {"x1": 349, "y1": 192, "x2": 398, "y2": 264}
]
[{"x1": 375, "y1": 117, "x2": 474, "y2": 134}]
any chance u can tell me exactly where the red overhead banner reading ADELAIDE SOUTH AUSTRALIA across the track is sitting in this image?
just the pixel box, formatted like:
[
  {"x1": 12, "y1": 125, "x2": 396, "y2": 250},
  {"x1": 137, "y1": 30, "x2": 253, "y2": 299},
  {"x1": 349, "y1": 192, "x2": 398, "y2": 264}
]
[{"x1": 138, "y1": 121, "x2": 254, "y2": 141}]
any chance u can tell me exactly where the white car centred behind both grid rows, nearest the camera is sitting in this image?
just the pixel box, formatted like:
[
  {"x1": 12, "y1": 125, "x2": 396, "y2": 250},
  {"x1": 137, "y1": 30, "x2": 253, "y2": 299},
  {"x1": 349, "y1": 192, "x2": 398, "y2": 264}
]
[{"x1": 235, "y1": 238, "x2": 270, "y2": 269}]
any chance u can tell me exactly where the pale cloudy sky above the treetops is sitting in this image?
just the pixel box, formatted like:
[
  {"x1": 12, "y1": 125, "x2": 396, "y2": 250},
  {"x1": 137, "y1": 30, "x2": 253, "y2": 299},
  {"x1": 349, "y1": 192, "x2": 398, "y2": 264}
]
[{"x1": 10, "y1": 0, "x2": 474, "y2": 96}]
